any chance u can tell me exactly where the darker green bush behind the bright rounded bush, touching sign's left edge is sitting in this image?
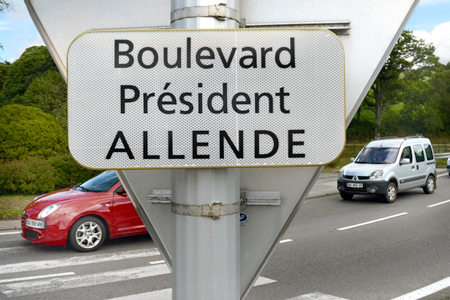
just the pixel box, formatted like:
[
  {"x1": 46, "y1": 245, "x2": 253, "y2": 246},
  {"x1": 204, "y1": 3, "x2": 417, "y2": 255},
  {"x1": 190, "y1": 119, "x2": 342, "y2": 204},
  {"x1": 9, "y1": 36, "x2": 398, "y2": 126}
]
[{"x1": 21, "y1": 70, "x2": 67, "y2": 129}]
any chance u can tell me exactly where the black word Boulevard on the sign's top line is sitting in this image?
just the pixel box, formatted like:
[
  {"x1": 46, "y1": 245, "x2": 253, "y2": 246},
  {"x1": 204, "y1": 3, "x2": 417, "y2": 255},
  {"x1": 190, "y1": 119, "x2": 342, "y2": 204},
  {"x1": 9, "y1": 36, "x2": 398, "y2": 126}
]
[{"x1": 114, "y1": 37, "x2": 295, "y2": 69}]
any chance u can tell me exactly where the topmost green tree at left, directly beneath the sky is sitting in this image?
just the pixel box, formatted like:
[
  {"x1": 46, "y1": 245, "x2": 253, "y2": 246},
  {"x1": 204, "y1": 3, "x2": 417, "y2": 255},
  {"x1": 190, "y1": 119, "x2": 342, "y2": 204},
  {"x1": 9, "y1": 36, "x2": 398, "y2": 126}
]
[{"x1": 0, "y1": 46, "x2": 58, "y2": 106}]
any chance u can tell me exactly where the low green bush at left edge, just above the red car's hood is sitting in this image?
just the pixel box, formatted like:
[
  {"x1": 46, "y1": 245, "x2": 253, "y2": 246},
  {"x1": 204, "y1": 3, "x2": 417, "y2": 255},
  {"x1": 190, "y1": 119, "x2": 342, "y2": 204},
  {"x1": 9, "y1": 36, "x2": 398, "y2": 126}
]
[{"x1": 0, "y1": 157, "x2": 57, "y2": 195}]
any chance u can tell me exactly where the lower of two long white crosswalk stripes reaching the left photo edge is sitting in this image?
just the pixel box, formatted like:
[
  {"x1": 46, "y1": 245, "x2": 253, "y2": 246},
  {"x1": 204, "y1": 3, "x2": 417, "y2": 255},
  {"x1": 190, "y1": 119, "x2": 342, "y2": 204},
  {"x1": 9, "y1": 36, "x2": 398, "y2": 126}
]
[{"x1": 0, "y1": 264, "x2": 170, "y2": 297}]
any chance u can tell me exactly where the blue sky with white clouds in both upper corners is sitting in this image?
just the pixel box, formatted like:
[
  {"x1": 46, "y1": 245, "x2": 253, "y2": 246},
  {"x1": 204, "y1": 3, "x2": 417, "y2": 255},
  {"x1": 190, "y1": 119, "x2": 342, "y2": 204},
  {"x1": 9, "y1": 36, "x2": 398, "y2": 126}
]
[{"x1": 0, "y1": 0, "x2": 450, "y2": 64}]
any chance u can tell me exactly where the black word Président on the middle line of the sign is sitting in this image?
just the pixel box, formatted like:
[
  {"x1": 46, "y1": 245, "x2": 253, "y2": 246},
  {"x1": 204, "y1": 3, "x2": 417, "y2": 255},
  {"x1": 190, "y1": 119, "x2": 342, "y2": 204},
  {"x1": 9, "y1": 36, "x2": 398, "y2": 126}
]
[{"x1": 120, "y1": 83, "x2": 290, "y2": 115}]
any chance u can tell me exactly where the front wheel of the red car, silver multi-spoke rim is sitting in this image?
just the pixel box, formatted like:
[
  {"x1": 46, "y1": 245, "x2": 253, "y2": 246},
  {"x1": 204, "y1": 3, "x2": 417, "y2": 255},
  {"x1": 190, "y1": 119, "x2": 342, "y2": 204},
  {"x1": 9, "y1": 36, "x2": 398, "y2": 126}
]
[{"x1": 69, "y1": 216, "x2": 106, "y2": 252}]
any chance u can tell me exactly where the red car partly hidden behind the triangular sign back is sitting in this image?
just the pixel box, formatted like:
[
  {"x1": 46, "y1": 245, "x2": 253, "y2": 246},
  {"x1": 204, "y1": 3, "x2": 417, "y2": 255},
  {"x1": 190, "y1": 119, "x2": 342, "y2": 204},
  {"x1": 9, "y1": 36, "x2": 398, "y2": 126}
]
[{"x1": 21, "y1": 171, "x2": 147, "y2": 251}]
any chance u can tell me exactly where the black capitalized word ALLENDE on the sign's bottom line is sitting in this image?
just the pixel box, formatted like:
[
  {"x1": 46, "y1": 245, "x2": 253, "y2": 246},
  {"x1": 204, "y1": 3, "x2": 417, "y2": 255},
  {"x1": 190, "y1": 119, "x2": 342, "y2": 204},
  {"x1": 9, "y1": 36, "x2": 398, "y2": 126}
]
[{"x1": 106, "y1": 129, "x2": 305, "y2": 160}]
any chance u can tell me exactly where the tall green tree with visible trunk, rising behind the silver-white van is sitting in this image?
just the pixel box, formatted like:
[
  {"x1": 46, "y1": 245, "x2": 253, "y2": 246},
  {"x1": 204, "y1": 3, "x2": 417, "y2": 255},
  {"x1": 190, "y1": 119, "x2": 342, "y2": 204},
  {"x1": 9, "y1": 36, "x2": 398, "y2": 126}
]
[{"x1": 364, "y1": 30, "x2": 439, "y2": 138}]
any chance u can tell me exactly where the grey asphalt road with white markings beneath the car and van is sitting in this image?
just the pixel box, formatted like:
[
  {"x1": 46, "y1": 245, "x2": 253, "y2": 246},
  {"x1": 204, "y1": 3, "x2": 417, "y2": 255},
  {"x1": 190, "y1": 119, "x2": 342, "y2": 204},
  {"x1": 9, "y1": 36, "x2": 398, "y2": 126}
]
[{"x1": 0, "y1": 174, "x2": 450, "y2": 300}]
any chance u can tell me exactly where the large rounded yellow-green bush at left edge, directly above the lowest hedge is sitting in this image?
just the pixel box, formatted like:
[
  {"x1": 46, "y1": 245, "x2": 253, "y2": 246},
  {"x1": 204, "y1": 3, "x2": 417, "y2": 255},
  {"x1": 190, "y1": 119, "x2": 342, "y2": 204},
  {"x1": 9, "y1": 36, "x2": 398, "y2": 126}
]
[{"x1": 0, "y1": 104, "x2": 67, "y2": 160}]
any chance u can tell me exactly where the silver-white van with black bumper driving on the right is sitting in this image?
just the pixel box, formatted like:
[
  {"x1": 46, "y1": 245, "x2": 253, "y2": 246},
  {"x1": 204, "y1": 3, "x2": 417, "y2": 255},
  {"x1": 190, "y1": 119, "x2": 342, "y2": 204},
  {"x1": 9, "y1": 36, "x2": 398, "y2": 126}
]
[{"x1": 337, "y1": 137, "x2": 436, "y2": 203}]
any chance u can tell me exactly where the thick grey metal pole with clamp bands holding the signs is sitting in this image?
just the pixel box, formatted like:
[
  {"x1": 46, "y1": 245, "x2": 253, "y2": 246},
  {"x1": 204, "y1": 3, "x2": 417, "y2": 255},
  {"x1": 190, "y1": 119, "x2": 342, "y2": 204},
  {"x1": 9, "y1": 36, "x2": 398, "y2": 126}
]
[{"x1": 171, "y1": 0, "x2": 240, "y2": 300}]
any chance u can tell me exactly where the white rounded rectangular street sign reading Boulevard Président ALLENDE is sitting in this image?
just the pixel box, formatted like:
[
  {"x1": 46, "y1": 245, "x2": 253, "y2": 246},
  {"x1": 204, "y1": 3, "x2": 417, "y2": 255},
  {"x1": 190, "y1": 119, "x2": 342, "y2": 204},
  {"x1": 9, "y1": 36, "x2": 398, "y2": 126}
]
[{"x1": 68, "y1": 29, "x2": 346, "y2": 169}]
